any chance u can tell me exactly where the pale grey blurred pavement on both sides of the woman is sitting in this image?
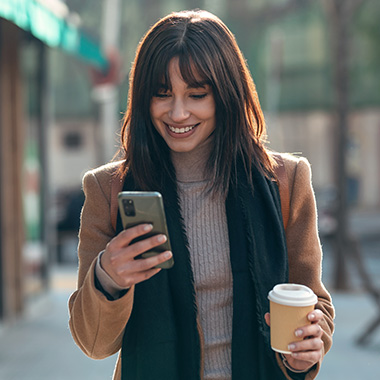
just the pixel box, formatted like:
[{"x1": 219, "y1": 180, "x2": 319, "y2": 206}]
[{"x1": 0, "y1": 266, "x2": 380, "y2": 380}]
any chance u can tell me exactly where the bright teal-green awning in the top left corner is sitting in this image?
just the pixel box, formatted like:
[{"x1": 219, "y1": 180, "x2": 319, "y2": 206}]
[{"x1": 0, "y1": 0, "x2": 108, "y2": 69}]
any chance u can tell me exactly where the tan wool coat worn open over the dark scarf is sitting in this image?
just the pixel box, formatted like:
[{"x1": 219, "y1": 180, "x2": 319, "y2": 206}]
[{"x1": 69, "y1": 154, "x2": 334, "y2": 380}]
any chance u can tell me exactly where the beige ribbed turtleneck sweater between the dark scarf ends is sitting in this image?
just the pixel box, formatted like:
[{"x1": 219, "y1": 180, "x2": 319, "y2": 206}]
[{"x1": 172, "y1": 146, "x2": 232, "y2": 380}]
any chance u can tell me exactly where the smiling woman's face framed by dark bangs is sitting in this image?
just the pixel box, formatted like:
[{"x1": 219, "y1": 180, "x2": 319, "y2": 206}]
[{"x1": 150, "y1": 58, "x2": 215, "y2": 152}]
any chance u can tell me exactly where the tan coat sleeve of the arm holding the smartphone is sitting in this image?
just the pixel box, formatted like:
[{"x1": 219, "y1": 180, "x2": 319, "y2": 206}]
[{"x1": 69, "y1": 171, "x2": 134, "y2": 359}]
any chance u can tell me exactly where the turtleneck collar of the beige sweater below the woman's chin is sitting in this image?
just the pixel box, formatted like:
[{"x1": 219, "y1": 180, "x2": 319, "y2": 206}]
[{"x1": 170, "y1": 138, "x2": 213, "y2": 182}]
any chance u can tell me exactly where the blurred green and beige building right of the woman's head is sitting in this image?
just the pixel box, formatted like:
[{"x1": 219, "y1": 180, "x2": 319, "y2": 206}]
[{"x1": 230, "y1": 0, "x2": 380, "y2": 212}]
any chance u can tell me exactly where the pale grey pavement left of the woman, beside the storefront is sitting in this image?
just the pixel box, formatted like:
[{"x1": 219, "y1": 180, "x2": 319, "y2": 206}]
[{"x1": 0, "y1": 266, "x2": 116, "y2": 380}]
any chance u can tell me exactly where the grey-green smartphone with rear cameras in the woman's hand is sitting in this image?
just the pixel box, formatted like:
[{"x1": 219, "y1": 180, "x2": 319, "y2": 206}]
[{"x1": 118, "y1": 191, "x2": 174, "y2": 269}]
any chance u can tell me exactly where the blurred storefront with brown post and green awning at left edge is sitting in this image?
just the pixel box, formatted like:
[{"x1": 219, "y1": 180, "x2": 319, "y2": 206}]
[{"x1": 0, "y1": 0, "x2": 108, "y2": 320}]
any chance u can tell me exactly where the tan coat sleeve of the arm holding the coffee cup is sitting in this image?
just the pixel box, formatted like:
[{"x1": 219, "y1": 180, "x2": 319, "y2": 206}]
[{"x1": 278, "y1": 157, "x2": 335, "y2": 380}]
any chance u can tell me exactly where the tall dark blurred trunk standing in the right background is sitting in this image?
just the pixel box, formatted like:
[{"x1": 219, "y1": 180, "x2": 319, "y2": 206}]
[{"x1": 322, "y1": 0, "x2": 364, "y2": 290}]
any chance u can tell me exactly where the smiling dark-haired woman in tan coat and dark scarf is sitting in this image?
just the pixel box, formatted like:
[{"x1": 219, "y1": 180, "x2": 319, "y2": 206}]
[{"x1": 69, "y1": 11, "x2": 334, "y2": 380}]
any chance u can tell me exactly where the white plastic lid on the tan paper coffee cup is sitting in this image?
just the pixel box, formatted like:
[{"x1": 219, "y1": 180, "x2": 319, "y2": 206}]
[{"x1": 268, "y1": 284, "x2": 318, "y2": 306}]
